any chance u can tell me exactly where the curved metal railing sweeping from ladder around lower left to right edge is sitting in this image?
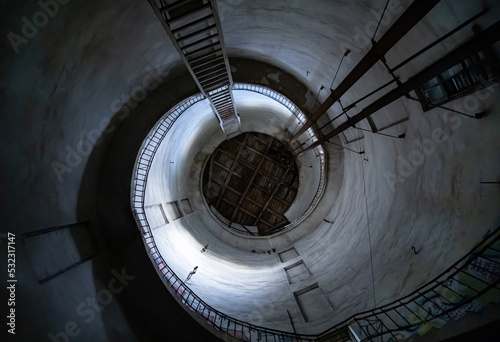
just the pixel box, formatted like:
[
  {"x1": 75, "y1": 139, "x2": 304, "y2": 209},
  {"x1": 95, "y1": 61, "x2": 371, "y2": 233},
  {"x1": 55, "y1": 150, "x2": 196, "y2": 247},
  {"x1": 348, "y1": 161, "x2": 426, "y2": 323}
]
[{"x1": 131, "y1": 86, "x2": 500, "y2": 342}]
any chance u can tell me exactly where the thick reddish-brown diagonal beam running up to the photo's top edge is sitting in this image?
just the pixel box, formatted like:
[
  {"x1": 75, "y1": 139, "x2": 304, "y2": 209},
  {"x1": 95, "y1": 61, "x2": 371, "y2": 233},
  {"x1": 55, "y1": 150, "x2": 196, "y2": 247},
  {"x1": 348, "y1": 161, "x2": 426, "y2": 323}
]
[{"x1": 290, "y1": 0, "x2": 440, "y2": 144}]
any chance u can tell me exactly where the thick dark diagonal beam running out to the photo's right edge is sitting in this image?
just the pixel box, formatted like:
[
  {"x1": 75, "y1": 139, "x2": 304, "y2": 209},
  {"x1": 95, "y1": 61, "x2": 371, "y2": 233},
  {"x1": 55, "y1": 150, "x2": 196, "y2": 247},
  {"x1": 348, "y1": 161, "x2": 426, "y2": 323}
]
[{"x1": 299, "y1": 21, "x2": 500, "y2": 155}]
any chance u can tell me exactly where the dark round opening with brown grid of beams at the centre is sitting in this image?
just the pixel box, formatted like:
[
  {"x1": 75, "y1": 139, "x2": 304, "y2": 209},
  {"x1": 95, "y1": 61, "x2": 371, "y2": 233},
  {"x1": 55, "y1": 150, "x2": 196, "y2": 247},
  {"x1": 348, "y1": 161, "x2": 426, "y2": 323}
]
[{"x1": 203, "y1": 132, "x2": 299, "y2": 236}]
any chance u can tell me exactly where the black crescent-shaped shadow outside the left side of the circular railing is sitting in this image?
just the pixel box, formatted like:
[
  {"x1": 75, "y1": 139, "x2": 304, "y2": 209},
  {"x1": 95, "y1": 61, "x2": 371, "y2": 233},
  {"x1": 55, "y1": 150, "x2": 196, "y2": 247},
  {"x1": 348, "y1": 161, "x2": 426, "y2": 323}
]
[{"x1": 74, "y1": 65, "x2": 223, "y2": 341}]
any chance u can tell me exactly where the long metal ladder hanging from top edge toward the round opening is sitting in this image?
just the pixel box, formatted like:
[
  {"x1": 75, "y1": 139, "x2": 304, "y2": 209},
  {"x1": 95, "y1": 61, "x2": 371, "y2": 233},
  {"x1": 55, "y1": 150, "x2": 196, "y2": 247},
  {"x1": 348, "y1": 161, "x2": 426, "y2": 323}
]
[{"x1": 148, "y1": 0, "x2": 241, "y2": 137}]
